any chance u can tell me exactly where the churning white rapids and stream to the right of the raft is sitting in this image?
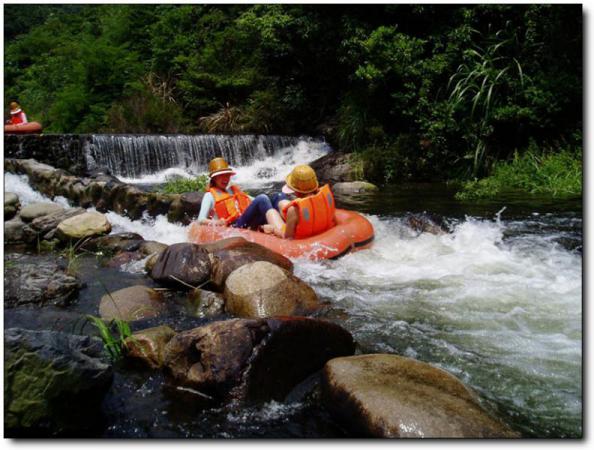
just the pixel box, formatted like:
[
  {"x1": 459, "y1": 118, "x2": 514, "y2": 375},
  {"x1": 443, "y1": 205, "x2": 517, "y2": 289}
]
[{"x1": 295, "y1": 217, "x2": 582, "y2": 433}]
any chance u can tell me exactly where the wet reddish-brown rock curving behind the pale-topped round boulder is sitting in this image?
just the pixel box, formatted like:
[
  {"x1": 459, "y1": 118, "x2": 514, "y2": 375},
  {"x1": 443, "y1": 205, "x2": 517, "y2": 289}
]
[{"x1": 203, "y1": 237, "x2": 293, "y2": 290}]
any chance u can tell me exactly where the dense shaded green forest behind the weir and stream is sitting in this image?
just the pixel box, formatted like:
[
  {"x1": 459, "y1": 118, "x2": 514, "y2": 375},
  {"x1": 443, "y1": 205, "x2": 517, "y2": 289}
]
[{"x1": 4, "y1": 4, "x2": 583, "y2": 182}]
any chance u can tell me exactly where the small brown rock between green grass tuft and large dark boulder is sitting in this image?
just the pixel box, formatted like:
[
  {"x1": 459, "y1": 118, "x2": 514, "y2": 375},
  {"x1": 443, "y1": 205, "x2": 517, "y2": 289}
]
[{"x1": 125, "y1": 325, "x2": 175, "y2": 369}]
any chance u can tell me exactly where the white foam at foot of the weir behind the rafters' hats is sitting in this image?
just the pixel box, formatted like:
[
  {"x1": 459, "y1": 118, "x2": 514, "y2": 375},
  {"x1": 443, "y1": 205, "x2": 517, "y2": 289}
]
[{"x1": 114, "y1": 140, "x2": 330, "y2": 189}]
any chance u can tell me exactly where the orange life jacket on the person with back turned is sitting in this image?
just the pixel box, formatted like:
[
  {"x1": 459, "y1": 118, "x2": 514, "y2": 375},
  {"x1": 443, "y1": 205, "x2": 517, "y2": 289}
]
[{"x1": 283, "y1": 184, "x2": 336, "y2": 239}]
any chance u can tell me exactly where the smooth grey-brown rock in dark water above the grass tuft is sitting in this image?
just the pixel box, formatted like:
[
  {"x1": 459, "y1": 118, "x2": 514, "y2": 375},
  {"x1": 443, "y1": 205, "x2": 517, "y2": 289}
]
[{"x1": 99, "y1": 286, "x2": 165, "y2": 321}]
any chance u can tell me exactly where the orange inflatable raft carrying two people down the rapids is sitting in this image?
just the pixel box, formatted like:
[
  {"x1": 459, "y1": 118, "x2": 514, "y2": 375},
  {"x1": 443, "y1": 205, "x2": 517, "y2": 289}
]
[{"x1": 188, "y1": 209, "x2": 374, "y2": 260}]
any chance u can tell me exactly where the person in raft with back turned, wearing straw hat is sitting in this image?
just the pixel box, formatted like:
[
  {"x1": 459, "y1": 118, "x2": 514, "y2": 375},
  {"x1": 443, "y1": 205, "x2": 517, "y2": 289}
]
[{"x1": 270, "y1": 165, "x2": 336, "y2": 239}]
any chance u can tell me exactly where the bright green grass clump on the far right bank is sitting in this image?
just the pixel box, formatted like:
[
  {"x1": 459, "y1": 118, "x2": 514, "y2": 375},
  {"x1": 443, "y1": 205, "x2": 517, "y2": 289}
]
[{"x1": 456, "y1": 145, "x2": 582, "y2": 200}]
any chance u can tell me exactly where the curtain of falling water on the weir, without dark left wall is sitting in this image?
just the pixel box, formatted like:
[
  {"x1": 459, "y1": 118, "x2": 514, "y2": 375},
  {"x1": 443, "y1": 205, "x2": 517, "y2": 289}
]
[{"x1": 85, "y1": 135, "x2": 321, "y2": 178}]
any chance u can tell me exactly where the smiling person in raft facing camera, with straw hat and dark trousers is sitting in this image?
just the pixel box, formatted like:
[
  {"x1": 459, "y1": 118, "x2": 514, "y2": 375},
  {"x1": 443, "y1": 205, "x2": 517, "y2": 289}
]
[{"x1": 198, "y1": 158, "x2": 282, "y2": 233}]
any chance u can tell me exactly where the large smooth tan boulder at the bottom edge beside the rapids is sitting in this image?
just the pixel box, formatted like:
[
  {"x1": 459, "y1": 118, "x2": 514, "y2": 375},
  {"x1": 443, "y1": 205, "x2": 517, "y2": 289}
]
[{"x1": 322, "y1": 354, "x2": 518, "y2": 438}]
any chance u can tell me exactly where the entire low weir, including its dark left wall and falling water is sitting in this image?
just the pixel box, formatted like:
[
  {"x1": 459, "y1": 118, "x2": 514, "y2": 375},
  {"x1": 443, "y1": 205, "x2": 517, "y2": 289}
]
[{"x1": 4, "y1": 134, "x2": 329, "y2": 179}]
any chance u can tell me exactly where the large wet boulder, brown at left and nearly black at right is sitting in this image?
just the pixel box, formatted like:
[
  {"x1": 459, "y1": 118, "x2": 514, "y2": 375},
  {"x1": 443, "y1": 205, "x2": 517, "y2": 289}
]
[{"x1": 164, "y1": 317, "x2": 355, "y2": 401}]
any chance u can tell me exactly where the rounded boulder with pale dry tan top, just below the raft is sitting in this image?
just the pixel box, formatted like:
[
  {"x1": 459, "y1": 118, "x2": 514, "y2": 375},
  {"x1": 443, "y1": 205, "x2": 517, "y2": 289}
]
[{"x1": 223, "y1": 261, "x2": 320, "y2": 317}]
